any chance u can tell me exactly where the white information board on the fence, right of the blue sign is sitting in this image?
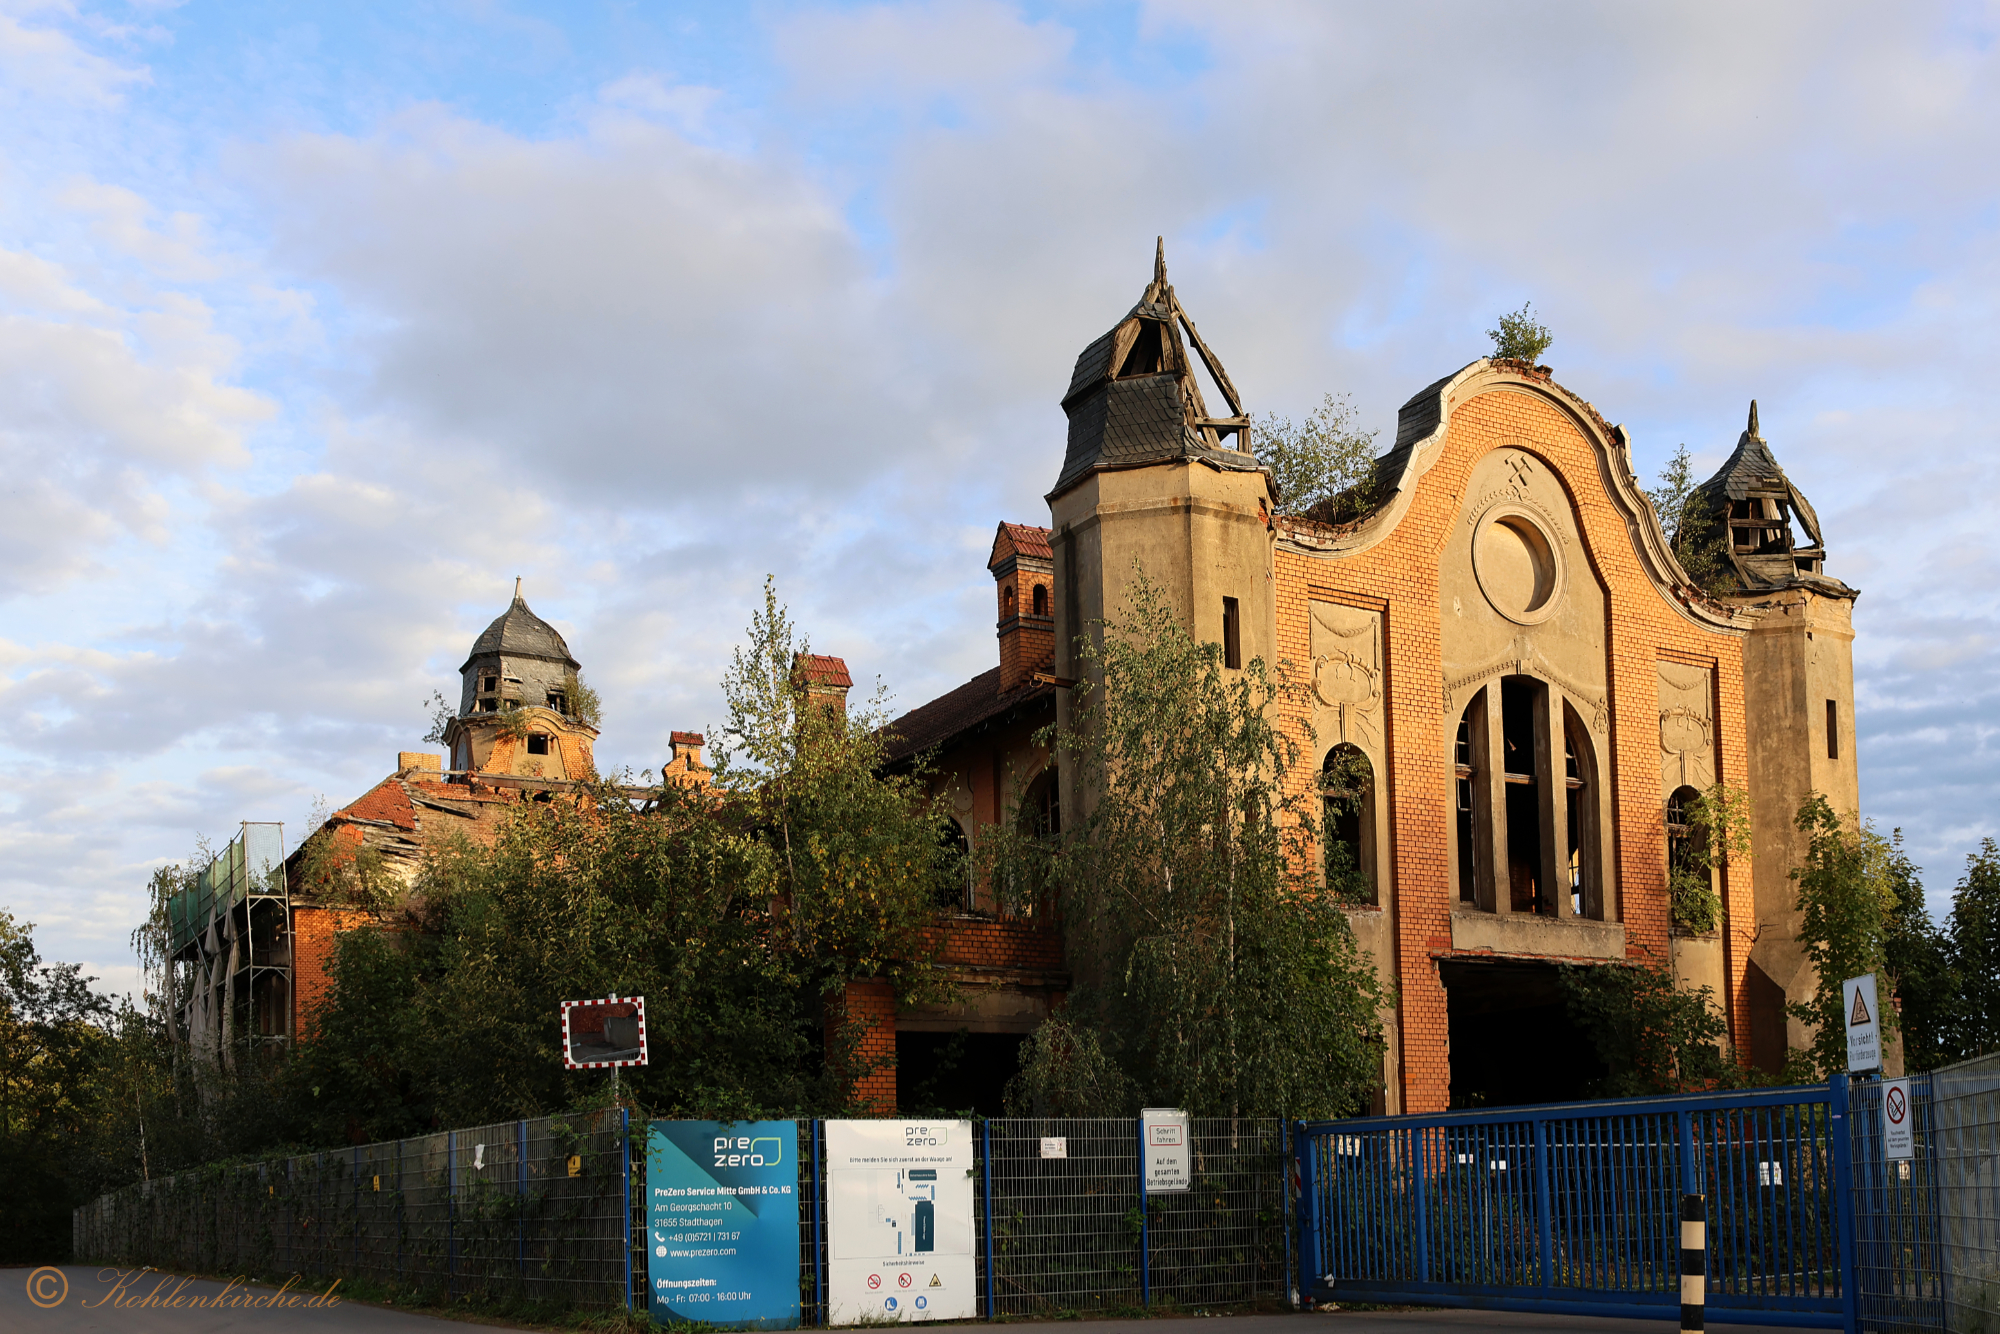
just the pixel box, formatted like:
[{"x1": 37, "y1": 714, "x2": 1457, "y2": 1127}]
[{"x1": 826, "y1": 1120, "x2": 978, "y2": 1324}]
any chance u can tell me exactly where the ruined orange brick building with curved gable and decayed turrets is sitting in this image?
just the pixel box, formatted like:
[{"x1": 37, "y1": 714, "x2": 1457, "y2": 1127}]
[{"x1": 164, "y1": 248, "x2": 1858, "y2": 1112}]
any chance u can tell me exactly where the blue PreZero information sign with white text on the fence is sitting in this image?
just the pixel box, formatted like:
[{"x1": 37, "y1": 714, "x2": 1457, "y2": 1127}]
[{"x1": 646, "y1": 1120, "x2": 800, "y2": 1328}]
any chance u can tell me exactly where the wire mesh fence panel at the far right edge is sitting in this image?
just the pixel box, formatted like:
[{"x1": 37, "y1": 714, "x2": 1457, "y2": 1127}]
[{"x1": 1930, "y1": 1054, "x2": 2000, "y2": 1334}]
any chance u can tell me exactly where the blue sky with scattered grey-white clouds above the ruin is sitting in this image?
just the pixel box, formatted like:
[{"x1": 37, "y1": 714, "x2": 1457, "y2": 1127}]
[{"x1": 0, "y1": 0, "x2": 2000, "y2": 986}]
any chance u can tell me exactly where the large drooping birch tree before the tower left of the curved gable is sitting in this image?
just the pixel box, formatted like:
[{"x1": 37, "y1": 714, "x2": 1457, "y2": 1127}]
[{"x1": 986, "y1": 574, "x2": 1382, "y2": 1116}]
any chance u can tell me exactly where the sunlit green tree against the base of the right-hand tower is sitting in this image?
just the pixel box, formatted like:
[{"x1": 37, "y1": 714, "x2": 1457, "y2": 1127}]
[{"x1": 1786, "y1": 792, "x2": 1898, "y2": 1082}]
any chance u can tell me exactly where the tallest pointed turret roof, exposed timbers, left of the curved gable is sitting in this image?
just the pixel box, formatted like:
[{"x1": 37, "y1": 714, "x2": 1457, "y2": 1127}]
[{"x1": 1050, "y1": 238, "x2": 1260, "y2": 496}]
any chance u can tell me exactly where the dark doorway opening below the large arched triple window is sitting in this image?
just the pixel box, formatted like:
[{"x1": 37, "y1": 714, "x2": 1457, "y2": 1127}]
[{"x1": 1438, "y1": 960, "x2": 1608, "y2": 1108}]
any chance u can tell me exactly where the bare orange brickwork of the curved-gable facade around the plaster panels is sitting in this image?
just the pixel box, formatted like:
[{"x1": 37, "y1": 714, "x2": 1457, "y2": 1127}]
[{"x1": 1272, "y1": 386, "x2": 1756, "y2": 1112}]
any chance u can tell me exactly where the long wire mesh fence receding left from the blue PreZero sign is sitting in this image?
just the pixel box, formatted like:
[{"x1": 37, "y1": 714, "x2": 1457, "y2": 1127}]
[{"x1": 74, "y1": 1112, "x2": 630, "y2": 1306}]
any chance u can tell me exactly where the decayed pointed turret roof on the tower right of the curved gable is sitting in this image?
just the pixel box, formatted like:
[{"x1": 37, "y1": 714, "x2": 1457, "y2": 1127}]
[{"x1": 1694, "y1": 398, "x2": 1852, "y2": 592}]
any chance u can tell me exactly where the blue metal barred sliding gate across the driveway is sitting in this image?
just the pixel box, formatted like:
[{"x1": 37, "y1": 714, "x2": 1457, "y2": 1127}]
[{"x1": 1294, "y1": 1078, "x2": 1856, "y2": 1330}]
